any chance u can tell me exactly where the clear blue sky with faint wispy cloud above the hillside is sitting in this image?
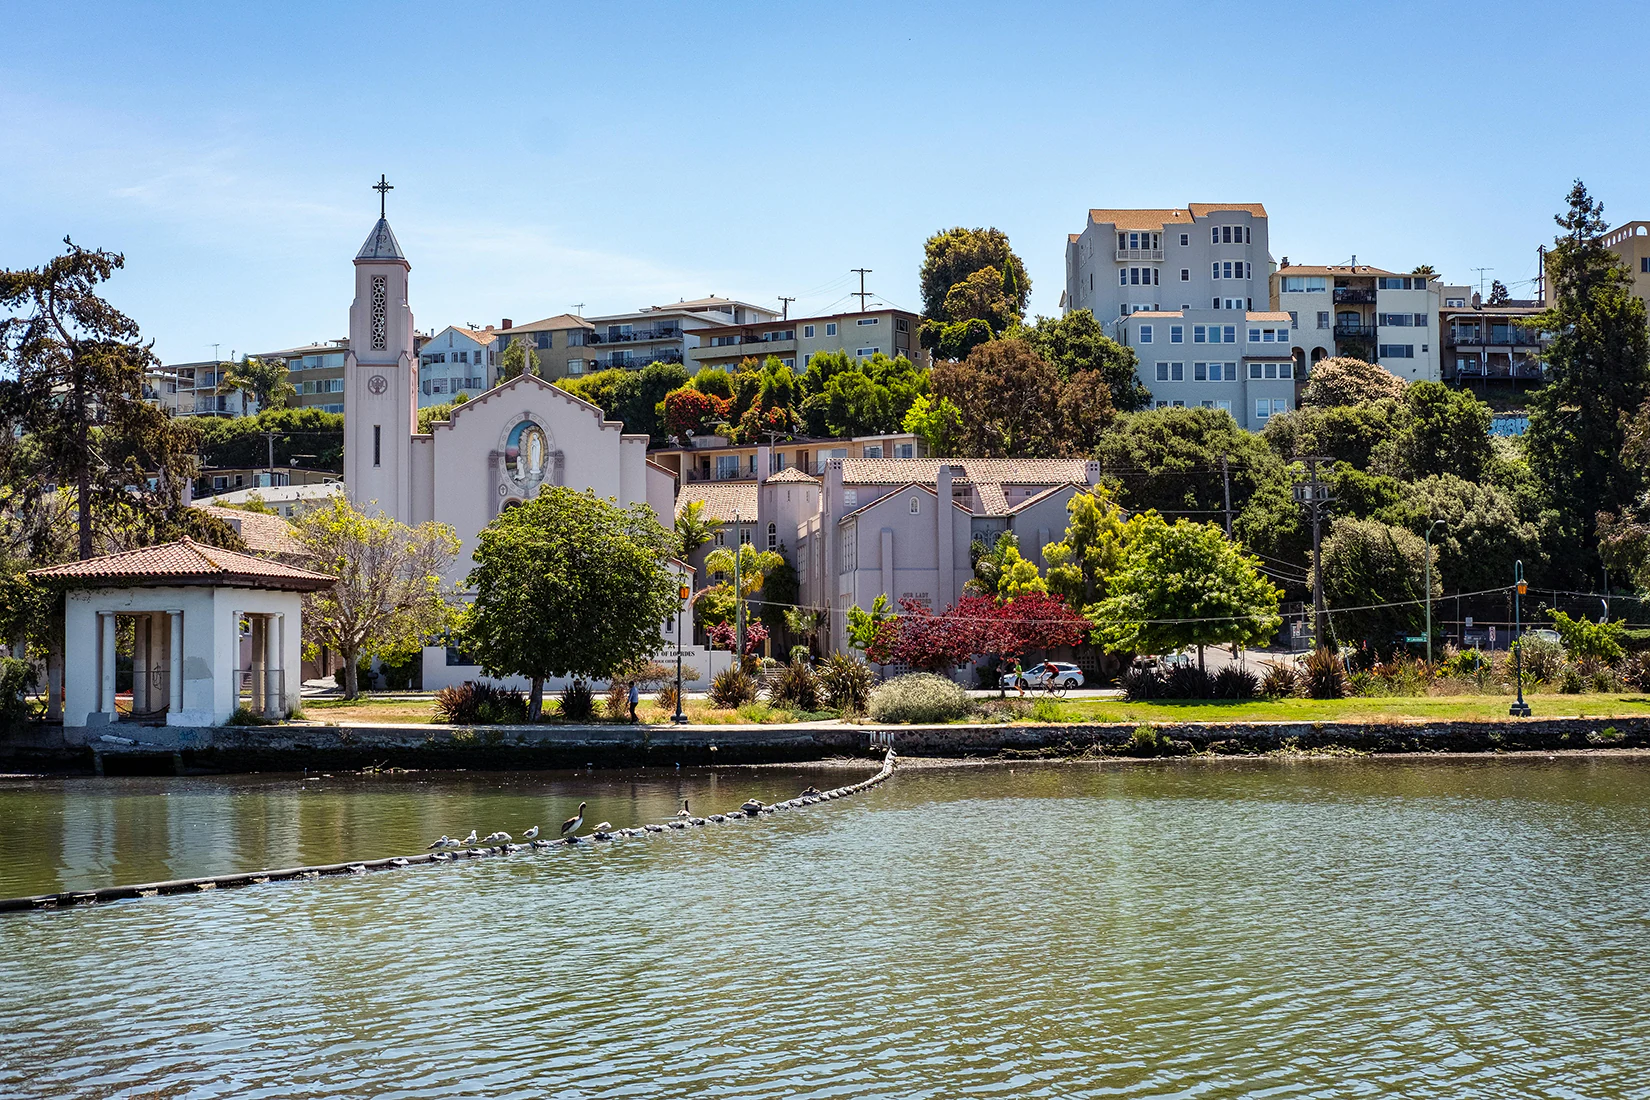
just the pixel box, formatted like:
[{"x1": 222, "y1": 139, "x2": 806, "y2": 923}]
[{"x1": 0, "y1": 0, "x2": 1650, "y2": 363}]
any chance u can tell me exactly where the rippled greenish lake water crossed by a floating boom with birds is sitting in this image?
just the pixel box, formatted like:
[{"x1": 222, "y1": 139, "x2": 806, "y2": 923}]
[{"x1": 0, "y1": 757, "x2": 1650, "y2": 1098}]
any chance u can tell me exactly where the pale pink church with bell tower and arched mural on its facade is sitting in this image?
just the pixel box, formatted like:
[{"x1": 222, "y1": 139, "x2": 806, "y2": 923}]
[{"x1": 343, "y1": 188, "x2": 683, "y2": 691}]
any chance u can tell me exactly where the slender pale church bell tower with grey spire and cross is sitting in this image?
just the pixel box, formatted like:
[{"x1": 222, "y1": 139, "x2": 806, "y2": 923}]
[{"x1": 343, "y1": 176, "x2": 417, "y2": 523}]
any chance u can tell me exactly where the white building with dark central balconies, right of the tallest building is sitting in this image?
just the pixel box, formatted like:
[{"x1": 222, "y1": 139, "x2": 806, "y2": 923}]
[{"x1": 1269, "y1": 256, "x2": 1442, "y2": 381}]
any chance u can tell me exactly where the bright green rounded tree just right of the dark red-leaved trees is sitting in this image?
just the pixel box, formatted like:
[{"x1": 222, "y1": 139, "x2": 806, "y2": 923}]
[{"x1": 1094, "y1": 516, "x2": 1284, "y2": 668}]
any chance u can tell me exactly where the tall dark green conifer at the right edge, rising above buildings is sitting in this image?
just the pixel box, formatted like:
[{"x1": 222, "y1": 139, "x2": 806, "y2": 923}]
[{"x1": 1525, "y1": 180, "x2": 1650, "y2": 574}]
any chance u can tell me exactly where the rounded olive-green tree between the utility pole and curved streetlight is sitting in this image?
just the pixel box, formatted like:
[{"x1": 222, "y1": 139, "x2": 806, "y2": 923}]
[{"x1": 1323, "y1": 518, "x2": 1444, "y2": 655}]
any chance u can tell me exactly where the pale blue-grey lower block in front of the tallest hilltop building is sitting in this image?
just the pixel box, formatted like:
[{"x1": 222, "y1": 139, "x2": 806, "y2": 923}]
[{"x1": 1117, "y1": 310, "x2": 1295, "y2": 432}]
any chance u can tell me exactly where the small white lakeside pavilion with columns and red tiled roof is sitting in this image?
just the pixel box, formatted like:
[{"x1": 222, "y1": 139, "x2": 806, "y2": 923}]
[{"x1": 28, "y1": 539, "x2": 337, "y2": 726}]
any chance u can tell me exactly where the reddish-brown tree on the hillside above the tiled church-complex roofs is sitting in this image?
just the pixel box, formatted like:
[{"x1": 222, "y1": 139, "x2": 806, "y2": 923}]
[{"x1": 932, "y1": 340, "x2": 1068, "y2": 458}]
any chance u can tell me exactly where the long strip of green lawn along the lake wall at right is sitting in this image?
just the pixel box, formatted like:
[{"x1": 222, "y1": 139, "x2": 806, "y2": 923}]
[{"x1": 1021, "y1": 693, "x2": 1650, "y2": 722}]
